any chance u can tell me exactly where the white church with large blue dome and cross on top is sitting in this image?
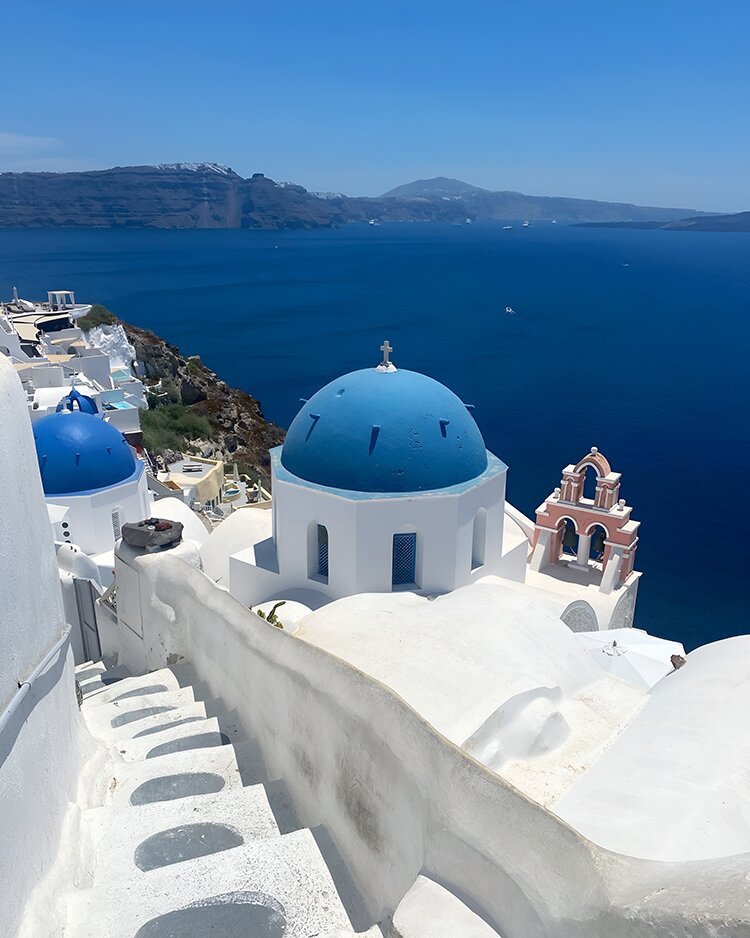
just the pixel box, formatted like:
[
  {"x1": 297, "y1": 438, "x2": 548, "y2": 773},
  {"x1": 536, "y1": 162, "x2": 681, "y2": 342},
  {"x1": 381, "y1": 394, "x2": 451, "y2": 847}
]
[{"x1": 229, "y1": 341, "x2": 512, "y2": 608}]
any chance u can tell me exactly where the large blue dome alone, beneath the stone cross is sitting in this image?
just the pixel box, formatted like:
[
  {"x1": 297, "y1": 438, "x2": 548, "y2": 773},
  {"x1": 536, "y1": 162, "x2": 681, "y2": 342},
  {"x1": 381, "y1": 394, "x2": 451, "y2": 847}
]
[{"x1": 281, "y1": 368, "x2": 487, "y2": 492}]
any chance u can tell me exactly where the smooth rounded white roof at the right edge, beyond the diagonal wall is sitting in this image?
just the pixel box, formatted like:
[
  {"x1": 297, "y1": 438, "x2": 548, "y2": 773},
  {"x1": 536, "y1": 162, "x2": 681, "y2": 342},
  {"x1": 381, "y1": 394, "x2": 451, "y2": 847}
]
[{"x1": 555, "y1": 635, "x2": 750, "y2": 860}]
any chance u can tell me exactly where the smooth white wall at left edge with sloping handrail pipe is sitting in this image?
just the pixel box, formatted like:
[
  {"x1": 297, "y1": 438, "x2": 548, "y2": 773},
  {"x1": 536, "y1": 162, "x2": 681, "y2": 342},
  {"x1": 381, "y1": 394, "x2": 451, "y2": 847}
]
[{"x1": 0, "y1": 356, "x2": 84, "y2": 938}]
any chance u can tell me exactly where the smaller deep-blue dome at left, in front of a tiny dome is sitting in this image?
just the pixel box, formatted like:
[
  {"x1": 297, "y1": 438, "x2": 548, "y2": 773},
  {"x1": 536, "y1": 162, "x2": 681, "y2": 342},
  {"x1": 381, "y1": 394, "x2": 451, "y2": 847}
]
[{"x1": 33, "y1": 410, "x2": 138, "y2": 495}]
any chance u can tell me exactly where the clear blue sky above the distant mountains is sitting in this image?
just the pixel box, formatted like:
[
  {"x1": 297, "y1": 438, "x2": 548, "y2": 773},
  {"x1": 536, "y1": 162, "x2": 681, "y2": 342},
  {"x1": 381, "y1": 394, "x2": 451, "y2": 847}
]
[{"x1": 0, "y1": 0, "x2": 750, "y2": 211}]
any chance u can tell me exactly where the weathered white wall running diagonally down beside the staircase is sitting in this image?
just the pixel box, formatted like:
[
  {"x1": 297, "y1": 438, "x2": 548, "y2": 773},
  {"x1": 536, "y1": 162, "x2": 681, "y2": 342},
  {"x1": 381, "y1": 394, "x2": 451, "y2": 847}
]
[{"x1": 114, "y1": 552, "x2": 750, "y2": 938}]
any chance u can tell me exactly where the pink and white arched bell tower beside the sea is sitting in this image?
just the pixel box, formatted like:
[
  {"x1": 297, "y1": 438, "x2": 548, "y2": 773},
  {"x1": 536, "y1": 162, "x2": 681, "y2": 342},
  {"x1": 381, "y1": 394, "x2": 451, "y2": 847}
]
[{"x1": 530, "y1": 446, "x2": 640, "y2": 594}]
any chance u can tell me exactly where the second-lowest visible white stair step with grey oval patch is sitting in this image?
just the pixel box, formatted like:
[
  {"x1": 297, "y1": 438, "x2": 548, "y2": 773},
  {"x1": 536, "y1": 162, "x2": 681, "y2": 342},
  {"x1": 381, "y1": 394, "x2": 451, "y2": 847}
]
[{"x1": 80, "y1": 785, "x2": 280, "y2": 886}]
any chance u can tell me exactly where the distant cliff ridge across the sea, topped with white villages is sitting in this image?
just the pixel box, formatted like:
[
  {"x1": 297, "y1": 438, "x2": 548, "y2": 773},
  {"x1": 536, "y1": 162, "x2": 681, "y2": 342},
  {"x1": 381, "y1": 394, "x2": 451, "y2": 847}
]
[{"x1": 0, "y1": 163, "x2": 712, "y2": 229}]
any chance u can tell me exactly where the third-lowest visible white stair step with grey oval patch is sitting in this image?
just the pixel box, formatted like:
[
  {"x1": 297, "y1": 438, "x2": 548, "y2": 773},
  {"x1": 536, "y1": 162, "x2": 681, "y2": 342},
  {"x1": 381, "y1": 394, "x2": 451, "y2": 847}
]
[{"x1": 97, "y1": 746, "x2": 247, "y2": 807}]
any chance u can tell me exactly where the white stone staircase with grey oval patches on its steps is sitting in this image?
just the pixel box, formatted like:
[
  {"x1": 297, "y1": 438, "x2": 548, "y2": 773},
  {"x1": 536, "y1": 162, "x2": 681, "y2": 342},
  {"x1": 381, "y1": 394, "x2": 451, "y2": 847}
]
[{"x1": 59, "y1": 662, "x2": 381, "y2": 938}]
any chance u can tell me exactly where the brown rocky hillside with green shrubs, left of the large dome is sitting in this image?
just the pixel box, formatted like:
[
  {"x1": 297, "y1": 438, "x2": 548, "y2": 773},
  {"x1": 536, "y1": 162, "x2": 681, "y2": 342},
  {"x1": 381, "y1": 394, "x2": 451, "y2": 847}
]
[{"x1": 113, "y1": 323, "x2": 284, "y2": 487}]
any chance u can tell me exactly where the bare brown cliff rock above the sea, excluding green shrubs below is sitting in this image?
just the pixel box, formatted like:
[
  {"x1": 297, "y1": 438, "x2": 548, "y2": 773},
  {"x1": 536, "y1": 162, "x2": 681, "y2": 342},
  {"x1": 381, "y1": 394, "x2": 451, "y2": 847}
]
[{"x1": 122, "y1": 323, "x2": 284, "y2": 487}]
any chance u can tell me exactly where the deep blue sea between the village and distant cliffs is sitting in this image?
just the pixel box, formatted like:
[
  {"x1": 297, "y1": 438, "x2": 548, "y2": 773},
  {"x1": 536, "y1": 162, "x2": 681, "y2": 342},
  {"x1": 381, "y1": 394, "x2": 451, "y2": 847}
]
[{"x1": 0, "y1": 223, "x2": 750, "y2": 648}]
